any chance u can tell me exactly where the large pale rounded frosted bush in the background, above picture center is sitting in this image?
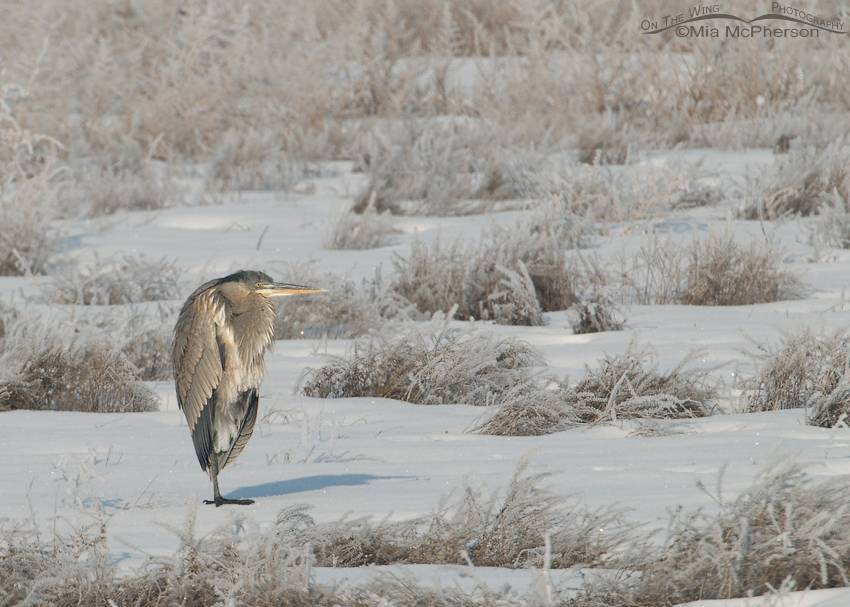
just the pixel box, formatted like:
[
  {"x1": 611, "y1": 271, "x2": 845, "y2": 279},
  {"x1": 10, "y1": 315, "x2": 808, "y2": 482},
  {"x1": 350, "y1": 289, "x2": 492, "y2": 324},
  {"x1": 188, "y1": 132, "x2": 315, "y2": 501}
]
[{"x1": 354, "y1": 119, "x2": 536, "y2": 216}]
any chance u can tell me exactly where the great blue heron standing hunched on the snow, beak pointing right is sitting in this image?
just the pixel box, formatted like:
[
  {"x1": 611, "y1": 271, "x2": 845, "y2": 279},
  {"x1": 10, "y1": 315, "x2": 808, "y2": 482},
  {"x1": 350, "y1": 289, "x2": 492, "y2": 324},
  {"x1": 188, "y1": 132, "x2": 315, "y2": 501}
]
[{"x1": 172, "y1": 270, "x2": 322, "y2": 506}]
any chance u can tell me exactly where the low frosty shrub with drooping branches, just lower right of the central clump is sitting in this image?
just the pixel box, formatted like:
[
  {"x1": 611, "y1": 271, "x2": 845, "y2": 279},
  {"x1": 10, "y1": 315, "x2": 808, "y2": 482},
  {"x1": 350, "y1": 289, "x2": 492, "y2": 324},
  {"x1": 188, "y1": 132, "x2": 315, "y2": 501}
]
[{"x1": 477, "y1": 341, "x2": 716, "y2": 436}]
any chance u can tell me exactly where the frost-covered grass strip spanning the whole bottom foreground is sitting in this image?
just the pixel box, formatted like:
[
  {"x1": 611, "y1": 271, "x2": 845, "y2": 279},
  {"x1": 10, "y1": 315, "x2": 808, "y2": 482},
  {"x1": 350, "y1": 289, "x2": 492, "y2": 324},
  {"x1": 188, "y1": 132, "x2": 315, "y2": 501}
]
[{"x1": 6, "y1": 455, "x2": 850, "y2": 607}]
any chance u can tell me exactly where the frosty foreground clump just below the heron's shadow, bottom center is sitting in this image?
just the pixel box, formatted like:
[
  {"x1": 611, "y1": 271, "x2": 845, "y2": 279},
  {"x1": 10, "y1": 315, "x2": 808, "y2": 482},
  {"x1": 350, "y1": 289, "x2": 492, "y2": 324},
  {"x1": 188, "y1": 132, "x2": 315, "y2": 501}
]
[{"x1": 302, "y1": 457, "x2": 634, "y2": 569}]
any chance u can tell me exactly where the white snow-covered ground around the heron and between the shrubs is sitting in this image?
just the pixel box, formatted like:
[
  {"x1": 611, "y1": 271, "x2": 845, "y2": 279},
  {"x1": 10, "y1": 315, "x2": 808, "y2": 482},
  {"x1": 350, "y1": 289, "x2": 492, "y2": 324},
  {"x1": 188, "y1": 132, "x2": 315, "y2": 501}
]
[{"x1": 0, "y1": 150, "x2": 850, "y2": 607}]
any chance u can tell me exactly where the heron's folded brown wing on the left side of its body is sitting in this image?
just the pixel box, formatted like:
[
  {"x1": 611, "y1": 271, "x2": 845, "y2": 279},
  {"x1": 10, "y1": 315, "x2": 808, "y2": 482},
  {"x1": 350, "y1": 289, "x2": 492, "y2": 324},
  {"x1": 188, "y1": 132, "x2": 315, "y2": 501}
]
[{"x1": 173, "y1": 292, "x2": 226, "y2": 470}]
